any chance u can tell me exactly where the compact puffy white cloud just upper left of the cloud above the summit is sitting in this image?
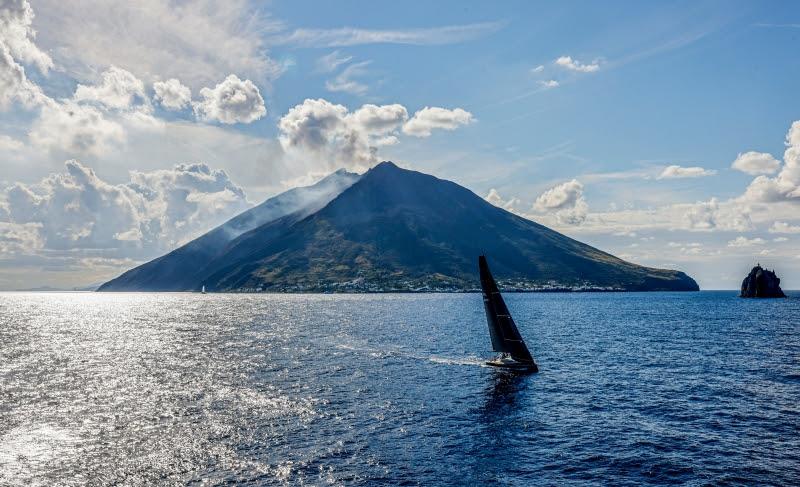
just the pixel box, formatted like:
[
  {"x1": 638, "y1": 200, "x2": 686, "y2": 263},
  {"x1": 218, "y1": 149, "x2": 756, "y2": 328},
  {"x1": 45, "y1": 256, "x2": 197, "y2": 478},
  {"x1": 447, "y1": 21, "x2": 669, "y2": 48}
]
[{"x1": 194, "y1": 74, "x2": 267, "y2": 124}]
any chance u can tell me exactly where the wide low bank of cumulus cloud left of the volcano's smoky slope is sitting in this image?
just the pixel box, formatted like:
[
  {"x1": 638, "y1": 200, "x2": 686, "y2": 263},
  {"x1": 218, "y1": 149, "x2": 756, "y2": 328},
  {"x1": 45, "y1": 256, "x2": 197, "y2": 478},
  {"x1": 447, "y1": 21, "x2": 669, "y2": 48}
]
[{"x1": 0, "y1": 160, "x2": 249, "y2": 257}]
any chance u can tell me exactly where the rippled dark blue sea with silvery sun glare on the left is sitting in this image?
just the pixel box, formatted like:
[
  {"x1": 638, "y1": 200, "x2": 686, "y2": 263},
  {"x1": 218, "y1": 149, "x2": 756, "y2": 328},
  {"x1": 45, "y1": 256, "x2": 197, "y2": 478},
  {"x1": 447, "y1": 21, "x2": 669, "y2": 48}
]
[{"x1": 0, "y1": 292, "x2": 800, "y2": 485}]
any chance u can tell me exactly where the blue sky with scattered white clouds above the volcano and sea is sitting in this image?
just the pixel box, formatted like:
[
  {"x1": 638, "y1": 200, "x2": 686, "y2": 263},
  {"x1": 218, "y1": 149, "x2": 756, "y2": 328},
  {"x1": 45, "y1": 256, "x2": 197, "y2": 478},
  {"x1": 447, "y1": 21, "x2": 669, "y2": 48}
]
[{"x1": 0, "y1": 0, "x2": 800, "y2": 290}]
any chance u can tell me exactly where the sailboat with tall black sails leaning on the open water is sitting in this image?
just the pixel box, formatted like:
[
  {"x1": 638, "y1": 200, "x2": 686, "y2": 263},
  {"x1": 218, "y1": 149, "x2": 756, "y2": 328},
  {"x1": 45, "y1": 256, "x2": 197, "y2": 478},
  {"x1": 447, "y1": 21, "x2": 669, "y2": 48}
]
[{"x1": 478, "y1": 255, "x2": 539, "y2": 372}]
